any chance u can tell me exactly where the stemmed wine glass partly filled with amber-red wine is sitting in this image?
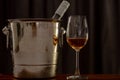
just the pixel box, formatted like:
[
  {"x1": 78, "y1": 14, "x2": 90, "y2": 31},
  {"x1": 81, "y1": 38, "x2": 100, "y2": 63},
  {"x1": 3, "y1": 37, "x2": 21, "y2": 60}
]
[{"x1": 66, "y1": 15, "x2": 88, "y2": 80}]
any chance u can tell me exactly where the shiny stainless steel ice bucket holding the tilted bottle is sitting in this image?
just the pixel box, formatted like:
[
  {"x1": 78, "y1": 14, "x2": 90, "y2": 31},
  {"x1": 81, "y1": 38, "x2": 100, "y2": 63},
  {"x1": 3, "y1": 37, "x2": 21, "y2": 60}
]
[{"x1": 3, "y1": 19, "x2": 60, "y2": 78}]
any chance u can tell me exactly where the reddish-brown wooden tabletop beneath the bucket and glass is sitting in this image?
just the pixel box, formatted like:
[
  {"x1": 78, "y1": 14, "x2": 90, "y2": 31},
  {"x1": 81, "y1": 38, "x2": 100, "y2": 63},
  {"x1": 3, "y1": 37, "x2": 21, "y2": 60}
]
[{"x1": 0, "y1": 74, "x2": 120, "y2": 80}]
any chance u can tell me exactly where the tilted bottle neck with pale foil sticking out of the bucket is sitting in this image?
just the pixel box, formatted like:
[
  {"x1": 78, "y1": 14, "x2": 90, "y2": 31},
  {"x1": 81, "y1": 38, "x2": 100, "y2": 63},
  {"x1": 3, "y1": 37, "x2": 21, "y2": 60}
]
[{"x1": 52, "y1": 0, "x2": 70, "y2": 20}]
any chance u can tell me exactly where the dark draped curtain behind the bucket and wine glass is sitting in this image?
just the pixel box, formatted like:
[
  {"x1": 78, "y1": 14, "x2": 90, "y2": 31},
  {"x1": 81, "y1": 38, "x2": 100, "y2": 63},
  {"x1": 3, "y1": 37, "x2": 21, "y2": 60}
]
[{"x1": 0, "y1": 0, "x2": 120, "y2": 74}]
